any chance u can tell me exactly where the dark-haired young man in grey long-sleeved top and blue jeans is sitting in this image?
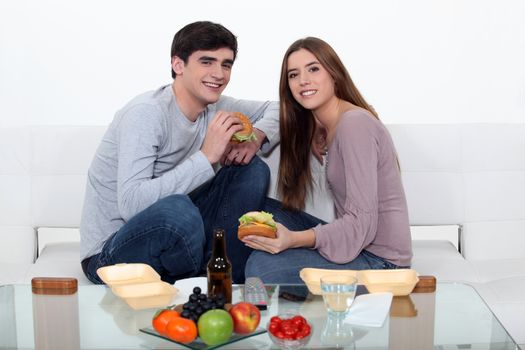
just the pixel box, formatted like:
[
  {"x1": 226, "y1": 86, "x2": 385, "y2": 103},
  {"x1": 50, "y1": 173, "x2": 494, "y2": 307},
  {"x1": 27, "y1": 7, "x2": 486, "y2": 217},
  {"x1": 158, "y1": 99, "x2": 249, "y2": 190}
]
[{"x1": 80, "y1": 22, "x2": 279, "y2": 283}]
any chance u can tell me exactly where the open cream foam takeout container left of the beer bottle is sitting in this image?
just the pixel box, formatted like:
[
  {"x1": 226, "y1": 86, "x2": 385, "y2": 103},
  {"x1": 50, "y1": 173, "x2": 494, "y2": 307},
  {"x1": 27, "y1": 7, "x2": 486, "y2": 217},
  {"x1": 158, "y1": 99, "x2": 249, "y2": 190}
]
[{"x1": 97, "y1": 263, "x2": 178, "y2": 309}]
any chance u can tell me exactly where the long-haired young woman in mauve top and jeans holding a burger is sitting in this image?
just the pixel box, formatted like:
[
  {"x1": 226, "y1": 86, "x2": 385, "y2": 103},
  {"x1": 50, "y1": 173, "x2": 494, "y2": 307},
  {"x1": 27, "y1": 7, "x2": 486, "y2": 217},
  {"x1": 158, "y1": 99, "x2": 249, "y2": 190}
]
[{"x1": 243, "y1": 37, "x2": 412, "y2": 283}]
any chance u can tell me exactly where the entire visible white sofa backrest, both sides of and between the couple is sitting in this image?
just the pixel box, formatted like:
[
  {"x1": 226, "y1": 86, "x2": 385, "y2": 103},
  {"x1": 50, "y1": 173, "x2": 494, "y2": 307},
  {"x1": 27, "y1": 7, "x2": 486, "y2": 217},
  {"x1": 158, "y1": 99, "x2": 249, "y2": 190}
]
[{"x1": 0, "y1": 124, "x2": 525, "y2": 259}]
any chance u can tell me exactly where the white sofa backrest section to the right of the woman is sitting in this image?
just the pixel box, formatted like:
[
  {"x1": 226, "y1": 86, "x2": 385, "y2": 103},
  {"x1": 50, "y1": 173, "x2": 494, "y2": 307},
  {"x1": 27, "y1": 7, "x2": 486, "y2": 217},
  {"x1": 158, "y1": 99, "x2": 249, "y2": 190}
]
[{"x1": 388, "y1": 124, "x2": 525, "y2": 260}]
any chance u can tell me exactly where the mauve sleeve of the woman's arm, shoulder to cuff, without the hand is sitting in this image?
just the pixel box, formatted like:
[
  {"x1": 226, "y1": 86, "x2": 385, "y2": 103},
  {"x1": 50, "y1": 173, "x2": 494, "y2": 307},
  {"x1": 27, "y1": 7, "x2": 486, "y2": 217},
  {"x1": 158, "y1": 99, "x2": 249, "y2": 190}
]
[{"x1": 314, "y1": 112, "x2": 379, "y2": 263}]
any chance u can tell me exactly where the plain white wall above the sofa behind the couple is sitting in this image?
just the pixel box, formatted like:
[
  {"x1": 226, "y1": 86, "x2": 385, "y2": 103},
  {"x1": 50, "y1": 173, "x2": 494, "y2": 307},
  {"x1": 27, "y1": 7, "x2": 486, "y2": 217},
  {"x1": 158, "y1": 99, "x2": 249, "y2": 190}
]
[{"x1": 0, "y1": 0, "x2": 525, "y2": 126}]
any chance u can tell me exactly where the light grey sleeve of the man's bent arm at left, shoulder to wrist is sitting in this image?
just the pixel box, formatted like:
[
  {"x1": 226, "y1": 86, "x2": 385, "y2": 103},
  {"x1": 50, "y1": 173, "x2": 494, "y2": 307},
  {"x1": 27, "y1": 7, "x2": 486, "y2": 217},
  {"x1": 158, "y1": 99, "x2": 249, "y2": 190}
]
[{"x1": 116, "y1": 104, "x2": 215, "y2": 220}]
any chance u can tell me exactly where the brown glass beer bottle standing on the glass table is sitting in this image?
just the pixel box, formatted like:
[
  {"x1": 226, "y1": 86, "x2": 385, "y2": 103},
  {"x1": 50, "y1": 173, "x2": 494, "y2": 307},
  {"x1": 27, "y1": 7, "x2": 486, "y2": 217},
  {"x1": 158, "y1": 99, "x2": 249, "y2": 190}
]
[{"x1": 207, "y1": 229, "x2": 232, "y2": 303}]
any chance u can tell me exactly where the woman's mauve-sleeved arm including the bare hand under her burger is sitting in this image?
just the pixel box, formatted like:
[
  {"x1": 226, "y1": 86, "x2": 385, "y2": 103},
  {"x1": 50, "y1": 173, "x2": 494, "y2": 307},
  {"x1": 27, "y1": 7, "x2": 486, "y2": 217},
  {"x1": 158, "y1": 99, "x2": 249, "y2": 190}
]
[{"x1": 243, "y1": 113, "x2": 378, "y2": 263}]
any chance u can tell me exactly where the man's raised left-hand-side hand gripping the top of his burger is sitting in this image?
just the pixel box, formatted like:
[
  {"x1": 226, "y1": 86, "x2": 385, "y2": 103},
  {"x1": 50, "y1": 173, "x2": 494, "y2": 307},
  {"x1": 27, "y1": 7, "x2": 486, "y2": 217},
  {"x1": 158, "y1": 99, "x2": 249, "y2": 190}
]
[{"x1": 201, "y1": 111, "x2": 244, "y2": 164}]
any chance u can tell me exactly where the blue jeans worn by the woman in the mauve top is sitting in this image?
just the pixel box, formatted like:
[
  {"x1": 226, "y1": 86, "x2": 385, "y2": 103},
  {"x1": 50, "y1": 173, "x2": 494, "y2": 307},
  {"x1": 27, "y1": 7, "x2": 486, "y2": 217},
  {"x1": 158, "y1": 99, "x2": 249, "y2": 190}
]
[{"x1": 245, "y1": 198, "x2": 400, "y2": 283}]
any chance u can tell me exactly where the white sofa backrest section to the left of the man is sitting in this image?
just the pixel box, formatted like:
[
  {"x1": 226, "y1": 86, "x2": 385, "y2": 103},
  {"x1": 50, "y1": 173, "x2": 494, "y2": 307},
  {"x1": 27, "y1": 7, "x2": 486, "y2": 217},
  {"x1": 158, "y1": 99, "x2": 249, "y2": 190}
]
[{"x1": 0, "y1": 126, "x2": 105, "y2": 227}]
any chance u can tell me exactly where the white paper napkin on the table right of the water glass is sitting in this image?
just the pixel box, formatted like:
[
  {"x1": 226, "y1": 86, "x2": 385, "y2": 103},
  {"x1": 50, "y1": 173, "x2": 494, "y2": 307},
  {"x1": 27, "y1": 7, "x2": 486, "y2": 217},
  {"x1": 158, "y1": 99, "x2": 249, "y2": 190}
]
[{"x1": 344, "y1": 292, "x2": 392, "y2": 327}]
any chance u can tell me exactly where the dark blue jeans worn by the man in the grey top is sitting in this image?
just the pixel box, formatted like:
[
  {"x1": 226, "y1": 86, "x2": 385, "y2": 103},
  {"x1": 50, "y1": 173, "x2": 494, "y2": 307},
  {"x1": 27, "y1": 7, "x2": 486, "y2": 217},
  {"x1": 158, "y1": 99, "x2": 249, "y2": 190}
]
[{"x1": 82, "y1": 157, "x2": 270, "y2": 283}]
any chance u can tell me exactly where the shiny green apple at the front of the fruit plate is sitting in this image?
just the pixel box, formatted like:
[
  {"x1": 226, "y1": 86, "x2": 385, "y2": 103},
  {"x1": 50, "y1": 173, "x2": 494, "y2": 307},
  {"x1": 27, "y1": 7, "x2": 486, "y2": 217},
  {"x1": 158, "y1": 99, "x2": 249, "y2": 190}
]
[{"x1": 197, "y1": 309, "x2": 233, "y2": 345}]
